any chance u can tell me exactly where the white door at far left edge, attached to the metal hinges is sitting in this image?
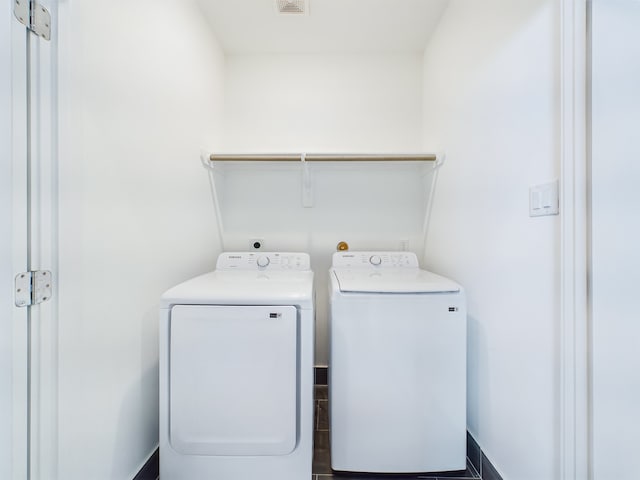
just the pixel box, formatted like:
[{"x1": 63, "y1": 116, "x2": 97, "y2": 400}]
[{"x1": 0, "y1": 2, "x2": 28, "y2": 479}]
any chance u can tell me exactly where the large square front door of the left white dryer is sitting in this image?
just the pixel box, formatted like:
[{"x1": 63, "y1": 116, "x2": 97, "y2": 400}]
[{"x1": 169, "y1": 305, "x2": 298, "y2": 455}]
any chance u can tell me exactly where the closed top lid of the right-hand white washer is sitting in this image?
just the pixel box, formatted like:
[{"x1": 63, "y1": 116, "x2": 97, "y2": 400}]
[{"x1": 333, "y1": 268, "x2": 460, "y2": 293}]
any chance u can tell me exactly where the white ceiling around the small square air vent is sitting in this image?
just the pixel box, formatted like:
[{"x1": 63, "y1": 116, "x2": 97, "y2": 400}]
[{"x1": 197, "y1": 0, "x2": 447, "y2": 54}]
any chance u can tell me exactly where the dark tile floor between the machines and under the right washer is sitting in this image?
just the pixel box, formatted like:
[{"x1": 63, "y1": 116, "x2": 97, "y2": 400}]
[{"x1": 312, "y1": 385, "x2": 480, "y2": 480}]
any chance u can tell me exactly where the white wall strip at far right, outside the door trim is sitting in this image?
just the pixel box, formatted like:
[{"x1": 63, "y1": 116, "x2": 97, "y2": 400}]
[{"x1": 591, "y1": 0, "x2": 640, "y2": 480}]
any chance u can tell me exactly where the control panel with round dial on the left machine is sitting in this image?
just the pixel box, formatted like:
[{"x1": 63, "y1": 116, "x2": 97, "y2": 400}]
[{"x1": 216, "y1": 252, "x2": 311, "y2": 271}]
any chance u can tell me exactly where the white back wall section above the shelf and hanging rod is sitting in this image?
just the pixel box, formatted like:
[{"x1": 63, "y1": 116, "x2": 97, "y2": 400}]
[{"x1": 222, "y1": 53, "x2": 421, "y2": 153}]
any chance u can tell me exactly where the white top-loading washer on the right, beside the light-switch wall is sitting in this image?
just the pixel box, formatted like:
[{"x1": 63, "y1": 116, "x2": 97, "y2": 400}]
[{"x1": 329, "y1": 252, "x2": 467, "y2": 473}]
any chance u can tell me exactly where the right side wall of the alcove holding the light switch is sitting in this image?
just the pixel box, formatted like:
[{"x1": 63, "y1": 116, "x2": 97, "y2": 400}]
[{"x1": 424, "y1": 0, "x2": 559, "y2": 480}]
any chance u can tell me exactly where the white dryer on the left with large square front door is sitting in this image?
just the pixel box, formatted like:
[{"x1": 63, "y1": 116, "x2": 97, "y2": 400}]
[{"x1": 159, "y1": 253, "x2": 314, "y2": 480}]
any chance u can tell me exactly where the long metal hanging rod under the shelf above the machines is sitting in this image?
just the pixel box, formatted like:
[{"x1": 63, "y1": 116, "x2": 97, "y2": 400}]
[{"x1": 209, "y1": 153, "x2": 437, "y2": 162}]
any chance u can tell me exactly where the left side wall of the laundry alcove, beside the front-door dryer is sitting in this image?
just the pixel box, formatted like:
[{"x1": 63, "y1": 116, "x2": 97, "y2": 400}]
[{"x1": 56, "y1": 0, "x2": 224, "y2": 480}]
